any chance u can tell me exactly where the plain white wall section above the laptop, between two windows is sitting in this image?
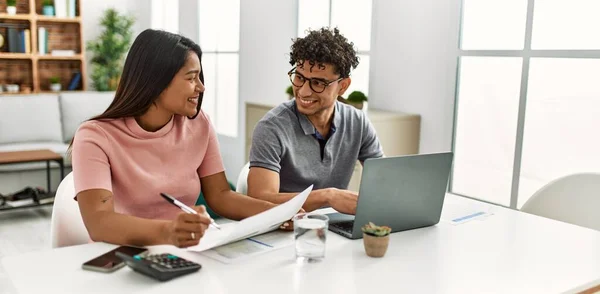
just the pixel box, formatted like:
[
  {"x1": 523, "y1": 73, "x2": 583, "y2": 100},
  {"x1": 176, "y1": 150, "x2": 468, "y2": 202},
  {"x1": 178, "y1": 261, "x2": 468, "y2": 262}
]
[{"x1": 369, "y1": 0, "x2": 461, "y2": 153}]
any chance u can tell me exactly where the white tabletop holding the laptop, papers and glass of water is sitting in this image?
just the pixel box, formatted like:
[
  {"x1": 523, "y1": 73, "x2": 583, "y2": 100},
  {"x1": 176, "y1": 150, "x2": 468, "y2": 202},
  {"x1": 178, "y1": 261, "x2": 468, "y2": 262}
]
[{"x1": 0, "y1": 195, "x2": 600, "y2": 294}]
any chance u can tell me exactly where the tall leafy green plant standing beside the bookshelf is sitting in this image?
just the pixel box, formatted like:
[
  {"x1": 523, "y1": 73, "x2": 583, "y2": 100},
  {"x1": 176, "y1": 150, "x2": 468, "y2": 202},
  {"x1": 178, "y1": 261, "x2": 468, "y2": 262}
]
[{"x1": 87, "y1": 9, "x2": 135, "y2": 91}]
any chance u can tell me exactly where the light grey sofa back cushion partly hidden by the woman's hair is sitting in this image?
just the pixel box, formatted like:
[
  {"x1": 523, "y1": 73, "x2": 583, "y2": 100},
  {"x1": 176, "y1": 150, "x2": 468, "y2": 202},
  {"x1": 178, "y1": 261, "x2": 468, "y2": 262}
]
[{"x1": 60, "y1": 92, "x2": 115, "y2": 142}]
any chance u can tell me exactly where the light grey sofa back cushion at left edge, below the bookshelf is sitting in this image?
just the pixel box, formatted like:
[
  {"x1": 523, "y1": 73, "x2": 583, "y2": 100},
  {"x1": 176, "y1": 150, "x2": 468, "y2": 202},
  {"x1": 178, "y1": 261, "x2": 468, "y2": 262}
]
[{"x1": 0, "y1": 94, "x2": 63, "y2": 144}]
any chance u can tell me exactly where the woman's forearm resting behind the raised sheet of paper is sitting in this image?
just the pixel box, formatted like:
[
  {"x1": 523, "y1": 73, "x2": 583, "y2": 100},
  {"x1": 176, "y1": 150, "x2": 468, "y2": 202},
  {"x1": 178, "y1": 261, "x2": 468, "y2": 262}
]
[{"x1": 206, "y1": 190, "x2": 277, "y2": 220}]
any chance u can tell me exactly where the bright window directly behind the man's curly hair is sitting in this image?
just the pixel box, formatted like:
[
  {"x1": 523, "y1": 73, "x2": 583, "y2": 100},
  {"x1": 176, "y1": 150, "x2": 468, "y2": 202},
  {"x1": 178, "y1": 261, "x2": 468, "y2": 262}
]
[{"x1": 298, "y1": 0, "x2": 373, "y2": 96}]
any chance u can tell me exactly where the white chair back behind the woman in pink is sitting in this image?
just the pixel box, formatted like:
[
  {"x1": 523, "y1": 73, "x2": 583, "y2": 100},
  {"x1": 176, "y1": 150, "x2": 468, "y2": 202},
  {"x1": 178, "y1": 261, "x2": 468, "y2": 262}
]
[{"x1": 50, "y1": 172, "x2": 90, "y2": 248}]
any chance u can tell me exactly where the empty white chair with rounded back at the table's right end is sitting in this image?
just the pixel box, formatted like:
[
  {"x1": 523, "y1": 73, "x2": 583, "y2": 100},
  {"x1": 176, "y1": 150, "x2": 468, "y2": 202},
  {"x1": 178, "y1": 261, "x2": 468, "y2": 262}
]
[{"x1": 521, "y1": 173, "x2": 600, "y2": 230}]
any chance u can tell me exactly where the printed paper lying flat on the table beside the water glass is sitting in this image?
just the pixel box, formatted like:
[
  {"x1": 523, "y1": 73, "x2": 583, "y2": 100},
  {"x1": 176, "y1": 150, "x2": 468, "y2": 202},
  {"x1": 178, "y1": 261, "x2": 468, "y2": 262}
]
[{"x1": 202, "y1": 231, "x2": 294, "y2": 263}]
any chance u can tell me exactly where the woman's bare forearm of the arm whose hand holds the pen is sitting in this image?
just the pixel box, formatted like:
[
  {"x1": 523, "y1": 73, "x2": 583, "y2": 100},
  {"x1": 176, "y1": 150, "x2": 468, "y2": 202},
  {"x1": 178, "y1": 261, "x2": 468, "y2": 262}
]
[{"x1": 85, "y1": 211, "x2": 169, "y2": 246}]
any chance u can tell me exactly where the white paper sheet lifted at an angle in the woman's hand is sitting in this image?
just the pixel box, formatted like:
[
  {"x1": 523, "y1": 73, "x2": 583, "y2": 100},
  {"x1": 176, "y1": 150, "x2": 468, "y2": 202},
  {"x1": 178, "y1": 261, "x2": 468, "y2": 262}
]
[{"x1": 188, "y1": 185, "x2": 313, "y2": 252}]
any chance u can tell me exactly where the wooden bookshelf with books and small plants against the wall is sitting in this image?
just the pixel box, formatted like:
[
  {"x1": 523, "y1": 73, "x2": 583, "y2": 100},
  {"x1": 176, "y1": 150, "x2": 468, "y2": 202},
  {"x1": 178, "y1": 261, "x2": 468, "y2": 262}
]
[{"x1": 0, "y1": 0, "x2": 87, "y2": 95}]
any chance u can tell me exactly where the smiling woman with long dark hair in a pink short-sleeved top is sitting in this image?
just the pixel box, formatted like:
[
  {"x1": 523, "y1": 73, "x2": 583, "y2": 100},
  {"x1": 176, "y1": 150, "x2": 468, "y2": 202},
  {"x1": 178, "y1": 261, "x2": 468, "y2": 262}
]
[{"x1": 72, "y1": 30, "x2": 275, "y2": 247}]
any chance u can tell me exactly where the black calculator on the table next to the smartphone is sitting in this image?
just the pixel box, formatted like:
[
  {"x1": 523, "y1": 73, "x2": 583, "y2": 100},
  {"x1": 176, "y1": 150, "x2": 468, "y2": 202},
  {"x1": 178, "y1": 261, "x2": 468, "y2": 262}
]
[{"x1": 116, "y1": 252, "x2": 202, "y2": 281}]
